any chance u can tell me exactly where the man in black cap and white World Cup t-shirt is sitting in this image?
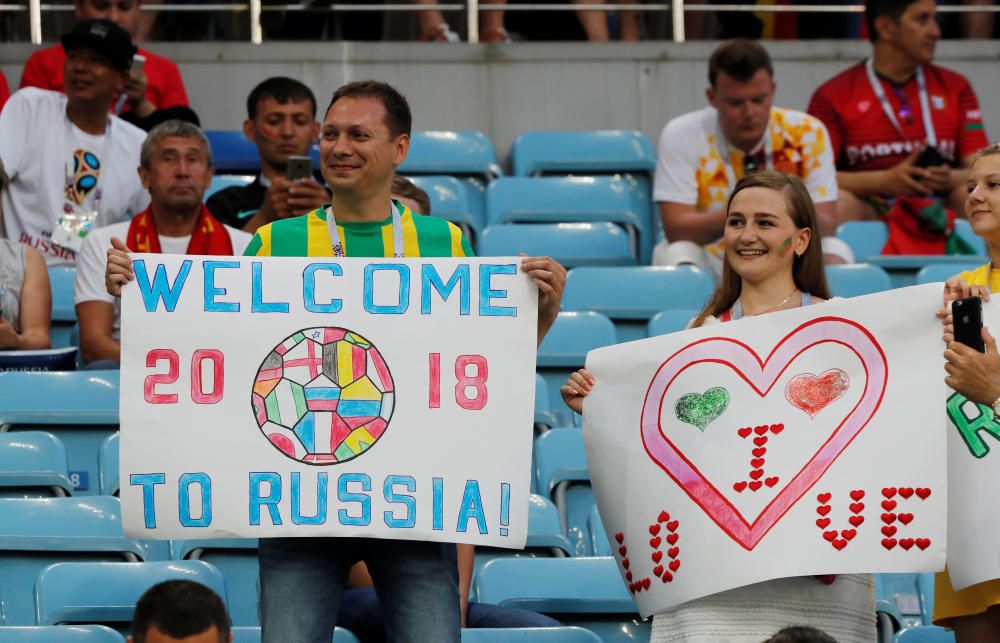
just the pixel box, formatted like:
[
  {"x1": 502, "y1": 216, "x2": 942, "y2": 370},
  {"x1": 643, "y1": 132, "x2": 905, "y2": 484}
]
[{"x1": 0, "y1": 20, "x2": 149, "y2": 266}]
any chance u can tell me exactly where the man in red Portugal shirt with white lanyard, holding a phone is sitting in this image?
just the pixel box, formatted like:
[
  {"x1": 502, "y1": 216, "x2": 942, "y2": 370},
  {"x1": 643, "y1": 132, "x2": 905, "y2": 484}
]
[{"x1": 808, "y1": 0, "x2": 987, "y2": 221}]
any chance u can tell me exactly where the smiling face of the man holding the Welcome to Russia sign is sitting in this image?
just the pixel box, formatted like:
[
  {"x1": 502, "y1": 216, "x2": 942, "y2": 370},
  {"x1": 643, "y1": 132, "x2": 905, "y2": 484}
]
[{"x1": 319, "y1": 96, "x2": 410, "y2": 198}]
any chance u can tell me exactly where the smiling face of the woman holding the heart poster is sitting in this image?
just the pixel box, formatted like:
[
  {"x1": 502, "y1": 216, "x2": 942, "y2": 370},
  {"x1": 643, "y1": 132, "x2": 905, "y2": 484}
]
[{"x1": 723, "y1": 187, "x2": 812, "y2": 283}]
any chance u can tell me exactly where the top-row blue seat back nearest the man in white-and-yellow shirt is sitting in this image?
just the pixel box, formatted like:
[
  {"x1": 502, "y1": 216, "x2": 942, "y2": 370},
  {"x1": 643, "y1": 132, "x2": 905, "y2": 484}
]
[{"x1": 511, "y1": 130, "x2": 656, "y2": 176}]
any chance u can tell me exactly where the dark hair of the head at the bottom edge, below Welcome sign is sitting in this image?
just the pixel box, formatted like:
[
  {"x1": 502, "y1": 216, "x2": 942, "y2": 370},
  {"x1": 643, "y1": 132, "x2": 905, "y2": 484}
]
[{"x1": 132, "y1": 580, "x2": 230, "y2": 643}]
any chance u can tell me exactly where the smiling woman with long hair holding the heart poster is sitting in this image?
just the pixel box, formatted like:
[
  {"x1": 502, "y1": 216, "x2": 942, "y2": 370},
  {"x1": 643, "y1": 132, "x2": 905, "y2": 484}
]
[{"x1": 560, "y1": 171, "x2": 875, "y2": 643}]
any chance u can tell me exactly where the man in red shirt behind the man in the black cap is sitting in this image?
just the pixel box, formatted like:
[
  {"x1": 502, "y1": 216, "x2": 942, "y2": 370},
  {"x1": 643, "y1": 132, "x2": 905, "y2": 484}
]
[{"x1": 21, "y1": 0, "x2": 188, "y2": 121}]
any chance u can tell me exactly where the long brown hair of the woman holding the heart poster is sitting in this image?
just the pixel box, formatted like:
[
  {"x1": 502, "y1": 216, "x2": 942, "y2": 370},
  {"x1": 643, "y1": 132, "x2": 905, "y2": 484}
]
[{"x1": 691, "y1": 170, "x2": 830, "y2": 328}]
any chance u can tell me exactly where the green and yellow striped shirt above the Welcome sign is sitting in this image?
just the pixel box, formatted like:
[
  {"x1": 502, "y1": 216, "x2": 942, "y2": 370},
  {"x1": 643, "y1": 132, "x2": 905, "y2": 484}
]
[{"x1": 244, "y1": 201, "x2": 474, "y2": 257}]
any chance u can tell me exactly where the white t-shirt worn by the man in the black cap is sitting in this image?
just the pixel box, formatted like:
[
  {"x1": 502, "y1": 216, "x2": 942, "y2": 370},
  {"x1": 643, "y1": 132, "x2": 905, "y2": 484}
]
[{"x1": 0, "y1": 87, "x2": 149, "y2": 266}]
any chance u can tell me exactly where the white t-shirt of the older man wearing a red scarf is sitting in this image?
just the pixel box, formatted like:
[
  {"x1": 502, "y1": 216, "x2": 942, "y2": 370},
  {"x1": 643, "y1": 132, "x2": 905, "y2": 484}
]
[{"x1": 73, "y1": 221, "x2": 253, "y2": 341}]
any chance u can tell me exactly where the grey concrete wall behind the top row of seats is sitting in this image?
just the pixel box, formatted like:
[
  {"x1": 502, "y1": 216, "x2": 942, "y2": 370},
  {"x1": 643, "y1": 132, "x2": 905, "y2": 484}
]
[{"x1": 0, "y1": 41, "x2": 1000, "y2": 167}]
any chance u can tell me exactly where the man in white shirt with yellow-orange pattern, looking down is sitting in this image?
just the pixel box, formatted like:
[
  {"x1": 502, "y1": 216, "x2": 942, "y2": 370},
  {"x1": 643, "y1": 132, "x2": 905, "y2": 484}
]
[{"x1": 653, "y1": 40, "x2": 853, "y2": 279}]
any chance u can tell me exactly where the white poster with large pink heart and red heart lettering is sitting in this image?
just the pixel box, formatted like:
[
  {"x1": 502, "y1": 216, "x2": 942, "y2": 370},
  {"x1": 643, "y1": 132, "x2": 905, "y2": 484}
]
[{"x1": 584, "y1": 284, "x2": 948, "y2": 616}]
